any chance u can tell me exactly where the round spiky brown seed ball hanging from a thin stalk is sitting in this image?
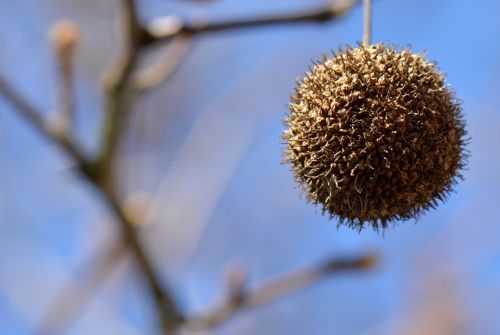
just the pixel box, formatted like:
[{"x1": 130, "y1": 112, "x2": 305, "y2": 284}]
[{"x1": 283, "y1": 44, "x2": 465, "y2": 229}]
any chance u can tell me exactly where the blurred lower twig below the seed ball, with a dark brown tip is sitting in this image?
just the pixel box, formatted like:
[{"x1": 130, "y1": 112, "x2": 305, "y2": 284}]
[{"x1": 185, "y1": 254, "x2": 377, "y2": 330}]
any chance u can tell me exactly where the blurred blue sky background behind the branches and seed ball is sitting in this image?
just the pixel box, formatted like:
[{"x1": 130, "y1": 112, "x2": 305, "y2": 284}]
[{"x1": 0, "y1": 0, "x2": 500, "y2": 335}]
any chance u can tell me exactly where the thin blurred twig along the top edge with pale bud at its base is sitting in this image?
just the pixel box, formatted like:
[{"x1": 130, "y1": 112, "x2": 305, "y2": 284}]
[{"x1": 145, "y1": 0, "x2": 359, "y2": 44}]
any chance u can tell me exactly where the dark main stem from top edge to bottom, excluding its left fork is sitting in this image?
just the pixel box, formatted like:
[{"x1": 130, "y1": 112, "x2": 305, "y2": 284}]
[{"x1": 94, "y1": 0, "x2": 186, "y2": 333}]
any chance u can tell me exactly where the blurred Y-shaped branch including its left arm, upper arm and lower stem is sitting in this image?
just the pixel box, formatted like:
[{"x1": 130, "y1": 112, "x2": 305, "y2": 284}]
[{"x1": 0, "y1": 0, "x2": 182, "y2": 333}]
